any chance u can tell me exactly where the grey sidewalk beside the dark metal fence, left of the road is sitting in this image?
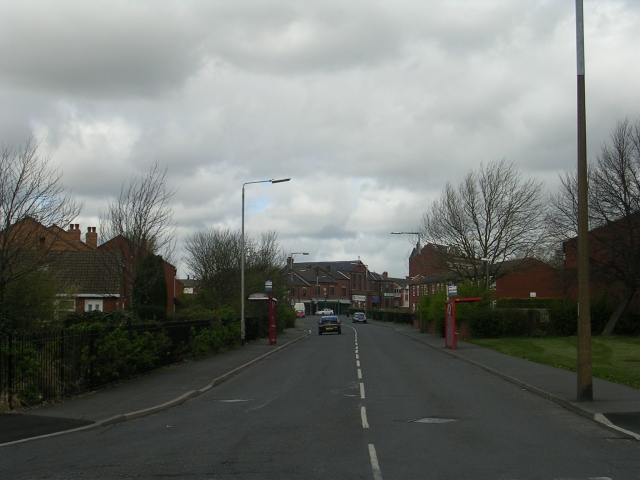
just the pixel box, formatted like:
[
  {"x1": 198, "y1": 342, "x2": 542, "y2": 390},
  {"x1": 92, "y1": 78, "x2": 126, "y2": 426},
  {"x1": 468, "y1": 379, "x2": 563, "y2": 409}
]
[{"x1": 0, "y1": 325, "x2": 309, "y2": 446}]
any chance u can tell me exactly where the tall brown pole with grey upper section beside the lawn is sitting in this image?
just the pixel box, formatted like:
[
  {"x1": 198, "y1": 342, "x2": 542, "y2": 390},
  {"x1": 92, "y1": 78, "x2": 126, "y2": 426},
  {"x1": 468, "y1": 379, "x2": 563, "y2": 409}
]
[{"x1": 576, "y1": 0, "x2": 593, "y2": 402}]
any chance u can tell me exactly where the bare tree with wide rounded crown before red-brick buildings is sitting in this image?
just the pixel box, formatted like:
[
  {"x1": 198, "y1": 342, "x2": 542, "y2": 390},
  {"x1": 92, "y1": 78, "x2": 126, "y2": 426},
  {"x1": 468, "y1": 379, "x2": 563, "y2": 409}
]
[{"x1": 421, "y1": 160, "x2": 545, "y2": 283}]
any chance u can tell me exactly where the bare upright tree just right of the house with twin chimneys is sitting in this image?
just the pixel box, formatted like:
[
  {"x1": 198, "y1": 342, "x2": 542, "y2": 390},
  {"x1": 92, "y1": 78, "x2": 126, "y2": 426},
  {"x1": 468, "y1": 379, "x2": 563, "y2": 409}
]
[{"x1": 100, "y1": 164, "x2": 176, "y2": 306}]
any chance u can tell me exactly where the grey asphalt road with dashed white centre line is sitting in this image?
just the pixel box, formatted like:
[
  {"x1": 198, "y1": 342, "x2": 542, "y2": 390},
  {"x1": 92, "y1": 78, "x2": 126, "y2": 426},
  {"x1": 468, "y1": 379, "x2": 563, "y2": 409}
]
[{"x1": 0, "y1": 318, "x2": 640, "y2": 480}]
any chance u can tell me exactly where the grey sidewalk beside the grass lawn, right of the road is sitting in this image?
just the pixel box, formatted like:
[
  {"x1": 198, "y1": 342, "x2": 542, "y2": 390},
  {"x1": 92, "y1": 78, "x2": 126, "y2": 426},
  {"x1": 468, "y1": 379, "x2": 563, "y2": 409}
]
[{"x1": 370, "y1": 320, "x2": 640, "y2": 440}]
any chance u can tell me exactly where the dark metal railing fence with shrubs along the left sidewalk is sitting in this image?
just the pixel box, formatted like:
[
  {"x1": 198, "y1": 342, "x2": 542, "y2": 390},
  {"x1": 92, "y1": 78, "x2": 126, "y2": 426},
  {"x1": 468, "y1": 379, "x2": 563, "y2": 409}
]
[{"x1": 0, "y1": 320, "x2": 210, "y2": 409}]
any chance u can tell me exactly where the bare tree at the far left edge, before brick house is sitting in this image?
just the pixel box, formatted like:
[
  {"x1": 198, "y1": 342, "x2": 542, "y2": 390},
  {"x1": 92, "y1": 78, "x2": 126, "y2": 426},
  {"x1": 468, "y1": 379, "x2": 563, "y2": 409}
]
[{"x1": 0, "y1": 137, "x2": 82, "y2": 318}]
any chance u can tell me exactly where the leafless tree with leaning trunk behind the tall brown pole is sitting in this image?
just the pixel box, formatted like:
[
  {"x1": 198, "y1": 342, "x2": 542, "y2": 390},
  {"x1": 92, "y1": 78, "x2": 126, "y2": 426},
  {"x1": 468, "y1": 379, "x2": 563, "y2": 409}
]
[{"x1": 549, "y1": 120, "x2": 640, "y2": 334}]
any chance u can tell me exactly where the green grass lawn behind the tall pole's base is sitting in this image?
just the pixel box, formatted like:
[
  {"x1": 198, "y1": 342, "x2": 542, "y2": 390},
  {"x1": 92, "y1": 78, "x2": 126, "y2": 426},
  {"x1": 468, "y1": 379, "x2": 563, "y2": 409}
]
[{"x1": 465, "y1": 336, "x2": 640, "y2": 389}]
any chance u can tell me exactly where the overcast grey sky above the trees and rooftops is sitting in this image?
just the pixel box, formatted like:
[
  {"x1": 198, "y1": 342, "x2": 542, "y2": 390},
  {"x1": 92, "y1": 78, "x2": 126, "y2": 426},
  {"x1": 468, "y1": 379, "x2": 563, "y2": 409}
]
[{"x1": 0, "y1": 0, "x2": 640, "y2": 277}]
